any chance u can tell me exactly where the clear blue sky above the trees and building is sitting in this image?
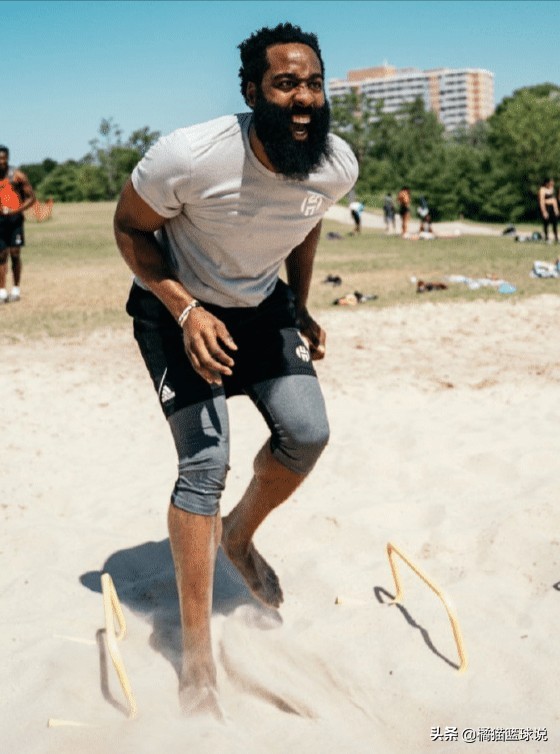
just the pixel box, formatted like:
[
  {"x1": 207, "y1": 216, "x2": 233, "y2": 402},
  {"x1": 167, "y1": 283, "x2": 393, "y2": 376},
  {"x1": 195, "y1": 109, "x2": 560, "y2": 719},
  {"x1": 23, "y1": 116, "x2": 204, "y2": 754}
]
[{"x1": 4, "y1": 0, "x2": 560, "y2": 165}]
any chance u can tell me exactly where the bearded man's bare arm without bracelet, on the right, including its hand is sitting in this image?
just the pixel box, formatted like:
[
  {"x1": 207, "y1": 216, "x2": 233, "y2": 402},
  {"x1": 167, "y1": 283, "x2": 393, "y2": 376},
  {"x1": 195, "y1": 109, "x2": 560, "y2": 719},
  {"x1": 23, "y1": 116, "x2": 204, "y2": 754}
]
[{"x1": 286, "y1": 222, "x2": 327, "y2": 360}]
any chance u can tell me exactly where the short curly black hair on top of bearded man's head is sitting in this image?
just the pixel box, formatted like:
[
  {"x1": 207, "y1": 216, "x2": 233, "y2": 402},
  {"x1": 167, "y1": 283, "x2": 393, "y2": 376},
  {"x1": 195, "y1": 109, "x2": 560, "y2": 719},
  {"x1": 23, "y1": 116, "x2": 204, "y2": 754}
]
[{"x1": 238, "y1": 23, "x2": 325, "y2": 101}]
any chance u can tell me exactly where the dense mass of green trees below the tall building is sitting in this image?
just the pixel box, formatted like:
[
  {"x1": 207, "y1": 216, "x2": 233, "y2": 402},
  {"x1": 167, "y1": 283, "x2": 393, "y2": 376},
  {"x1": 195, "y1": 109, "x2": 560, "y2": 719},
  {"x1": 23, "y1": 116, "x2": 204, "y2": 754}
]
[{"x1": 332, "y1": 83, "x2": 560, "y2": 222}]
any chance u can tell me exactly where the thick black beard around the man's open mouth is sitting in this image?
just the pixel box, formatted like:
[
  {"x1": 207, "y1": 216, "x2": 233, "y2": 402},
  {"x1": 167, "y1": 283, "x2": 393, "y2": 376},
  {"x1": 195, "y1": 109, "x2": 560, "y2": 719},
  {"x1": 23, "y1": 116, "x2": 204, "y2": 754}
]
[{"x1": 253, "y1": 90, "x2": 331, "y2": 181}]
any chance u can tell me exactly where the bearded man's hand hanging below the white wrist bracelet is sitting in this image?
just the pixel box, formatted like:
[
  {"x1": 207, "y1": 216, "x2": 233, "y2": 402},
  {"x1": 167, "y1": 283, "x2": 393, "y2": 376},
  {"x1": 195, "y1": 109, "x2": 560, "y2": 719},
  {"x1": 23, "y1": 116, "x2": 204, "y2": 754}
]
[{"x1": 183, "y1": 307, "x2": 237, "y2": 385}]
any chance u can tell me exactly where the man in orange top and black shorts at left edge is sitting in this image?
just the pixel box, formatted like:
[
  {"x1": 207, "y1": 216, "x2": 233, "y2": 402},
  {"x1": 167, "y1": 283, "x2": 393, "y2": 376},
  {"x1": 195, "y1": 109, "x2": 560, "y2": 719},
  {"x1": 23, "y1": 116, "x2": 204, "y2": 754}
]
[{"x1": 0, "y1": 146, "x2": 35, "y2": 304}]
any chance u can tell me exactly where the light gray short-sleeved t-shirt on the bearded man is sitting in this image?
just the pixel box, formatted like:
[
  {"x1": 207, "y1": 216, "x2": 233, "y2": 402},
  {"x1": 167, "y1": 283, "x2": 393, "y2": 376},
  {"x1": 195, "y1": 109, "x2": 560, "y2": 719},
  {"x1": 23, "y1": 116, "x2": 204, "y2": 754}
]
[{"x1": 132, "y1": 113, "x2": 358, "y2": 307}]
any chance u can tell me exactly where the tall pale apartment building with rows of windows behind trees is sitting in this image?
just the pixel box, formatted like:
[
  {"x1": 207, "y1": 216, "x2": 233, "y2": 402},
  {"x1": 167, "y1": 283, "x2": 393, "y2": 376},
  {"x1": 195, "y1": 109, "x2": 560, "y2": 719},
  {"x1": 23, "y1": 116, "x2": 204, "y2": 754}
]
[{"x1": 329, "y1": 65, "x2": 494, "y2": 131}]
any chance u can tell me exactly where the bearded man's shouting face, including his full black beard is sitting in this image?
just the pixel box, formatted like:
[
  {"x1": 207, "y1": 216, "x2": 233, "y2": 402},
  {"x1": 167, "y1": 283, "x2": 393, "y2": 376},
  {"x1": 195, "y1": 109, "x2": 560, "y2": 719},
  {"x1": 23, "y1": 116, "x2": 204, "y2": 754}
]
[{"x1": 248, "y1": 43, "x2": 330, "y2": 179}]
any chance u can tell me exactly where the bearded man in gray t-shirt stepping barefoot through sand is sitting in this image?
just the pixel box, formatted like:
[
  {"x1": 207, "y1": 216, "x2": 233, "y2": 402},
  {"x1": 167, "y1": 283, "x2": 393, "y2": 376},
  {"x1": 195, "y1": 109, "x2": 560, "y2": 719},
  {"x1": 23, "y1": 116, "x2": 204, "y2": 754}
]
[{"x1": 115, "y1": 23, "x2": 357, "y2": 717}]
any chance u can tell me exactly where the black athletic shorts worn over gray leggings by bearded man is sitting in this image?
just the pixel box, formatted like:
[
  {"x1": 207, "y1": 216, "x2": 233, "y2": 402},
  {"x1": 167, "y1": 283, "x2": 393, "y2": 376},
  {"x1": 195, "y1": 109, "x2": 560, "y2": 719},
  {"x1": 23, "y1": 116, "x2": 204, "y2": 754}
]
[{"x1": 126, "y1": 280, "x2": 316, "y2": 417}]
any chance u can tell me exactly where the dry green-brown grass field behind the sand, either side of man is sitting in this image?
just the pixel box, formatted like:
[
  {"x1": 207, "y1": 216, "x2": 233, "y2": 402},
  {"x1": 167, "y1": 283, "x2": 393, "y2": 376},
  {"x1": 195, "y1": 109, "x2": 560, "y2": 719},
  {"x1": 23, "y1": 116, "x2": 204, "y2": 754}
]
[{"x1": 0, "y1": 202, "x2": 560, "y2": 341}]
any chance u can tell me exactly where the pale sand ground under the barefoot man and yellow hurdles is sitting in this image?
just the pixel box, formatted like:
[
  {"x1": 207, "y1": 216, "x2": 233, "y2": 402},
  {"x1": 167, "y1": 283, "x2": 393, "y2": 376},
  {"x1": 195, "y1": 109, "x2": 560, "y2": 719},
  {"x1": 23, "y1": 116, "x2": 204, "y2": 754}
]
[{"x1": 0, "y1": 293, "x2": 560, "y2": 754}]
